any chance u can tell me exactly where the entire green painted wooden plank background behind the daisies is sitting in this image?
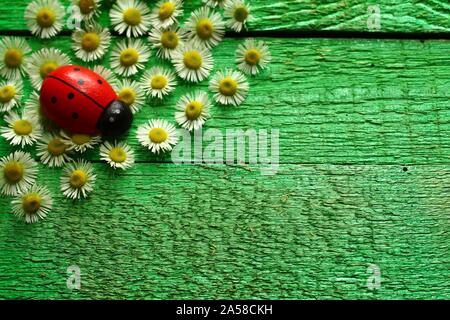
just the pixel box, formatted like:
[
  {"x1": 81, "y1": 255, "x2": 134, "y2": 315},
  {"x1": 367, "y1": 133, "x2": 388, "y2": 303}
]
[{"x1": 0, "y1": 0, "x2": 450, "y2": 299}]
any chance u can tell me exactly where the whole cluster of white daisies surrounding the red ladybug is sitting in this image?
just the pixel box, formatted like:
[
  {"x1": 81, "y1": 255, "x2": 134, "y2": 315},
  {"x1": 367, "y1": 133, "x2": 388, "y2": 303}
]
[{"x1": 0, "y1": 0, "x2": 271, "y2": 223}]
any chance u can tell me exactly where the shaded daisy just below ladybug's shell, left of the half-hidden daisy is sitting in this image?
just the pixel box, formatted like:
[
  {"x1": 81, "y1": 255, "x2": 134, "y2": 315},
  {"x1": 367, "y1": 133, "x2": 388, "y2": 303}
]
[{"x1": 37, "y1": 133, "x2": 72, "y2": 167}]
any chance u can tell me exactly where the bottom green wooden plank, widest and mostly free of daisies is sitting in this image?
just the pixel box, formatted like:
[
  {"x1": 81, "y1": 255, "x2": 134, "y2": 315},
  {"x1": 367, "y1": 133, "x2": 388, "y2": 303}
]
[{"x1": 0, "y1": 164, "x2": 450, "y2": 299}]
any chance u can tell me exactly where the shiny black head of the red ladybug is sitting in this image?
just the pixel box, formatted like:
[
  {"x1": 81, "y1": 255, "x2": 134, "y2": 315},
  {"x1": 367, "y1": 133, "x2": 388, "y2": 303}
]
[{"x1": 97, "y1": 100, "x2": 133, "y2": 138}]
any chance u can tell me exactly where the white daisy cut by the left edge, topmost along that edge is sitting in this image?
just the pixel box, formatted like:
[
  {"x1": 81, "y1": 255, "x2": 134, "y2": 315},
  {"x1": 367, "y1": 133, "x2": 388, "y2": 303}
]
[{"x1": 0, "y1": 37, "x2": 31, "y2": 79}]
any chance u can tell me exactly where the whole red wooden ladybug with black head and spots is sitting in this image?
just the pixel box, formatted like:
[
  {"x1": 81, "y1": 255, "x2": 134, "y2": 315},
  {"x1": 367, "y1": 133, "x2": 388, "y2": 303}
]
[{"x1": 40, "y1": 65, "x2": 133, "y2": 137}]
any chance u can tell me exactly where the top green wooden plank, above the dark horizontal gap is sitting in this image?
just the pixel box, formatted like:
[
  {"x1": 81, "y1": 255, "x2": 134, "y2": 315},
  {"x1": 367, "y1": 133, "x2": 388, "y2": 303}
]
[{"x1": 0, "y1": 0, "x2": 450, "y2": 32}]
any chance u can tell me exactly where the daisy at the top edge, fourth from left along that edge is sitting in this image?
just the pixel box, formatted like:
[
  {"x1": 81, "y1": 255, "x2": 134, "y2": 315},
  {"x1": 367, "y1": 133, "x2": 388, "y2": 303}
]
[{"x1": 150, "y1": 0, "x2": 183, "y2": 29}]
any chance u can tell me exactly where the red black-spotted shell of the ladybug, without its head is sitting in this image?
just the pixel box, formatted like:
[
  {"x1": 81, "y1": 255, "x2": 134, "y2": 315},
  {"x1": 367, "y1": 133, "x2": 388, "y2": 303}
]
[{"x1": 40, "y1": 66, "x2": 118, "y2": 134}]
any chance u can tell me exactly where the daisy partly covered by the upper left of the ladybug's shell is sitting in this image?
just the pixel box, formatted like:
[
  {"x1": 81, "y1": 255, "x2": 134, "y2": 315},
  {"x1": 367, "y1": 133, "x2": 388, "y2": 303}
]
[{"x1": 27, "y1": 48, "x2": 71, "y2": 91}]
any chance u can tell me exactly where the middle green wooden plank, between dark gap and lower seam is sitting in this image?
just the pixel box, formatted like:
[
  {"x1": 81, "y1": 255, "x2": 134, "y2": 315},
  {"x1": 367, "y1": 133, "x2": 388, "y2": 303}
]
[{"x1": 0, "y1": 37, "x2": 450, "y2": 164}]
